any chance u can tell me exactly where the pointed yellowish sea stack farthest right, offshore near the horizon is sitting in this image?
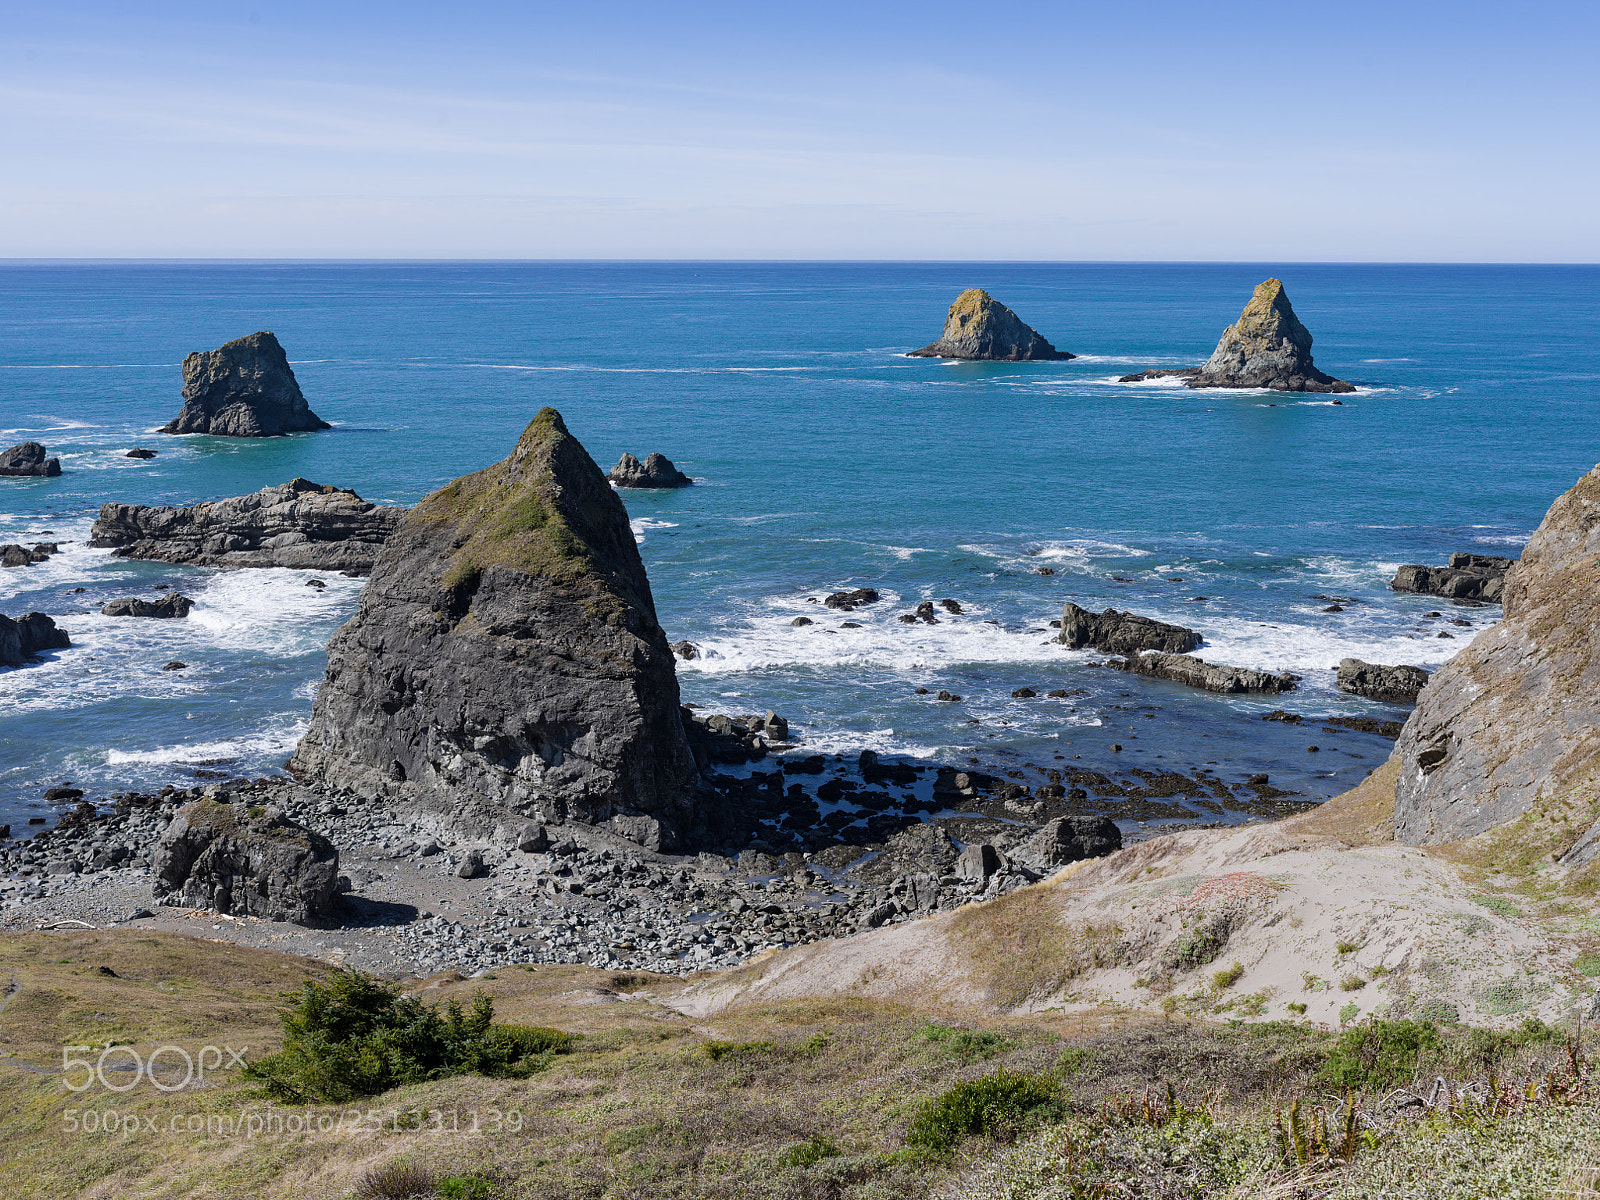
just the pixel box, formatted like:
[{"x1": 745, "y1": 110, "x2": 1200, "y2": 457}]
[{"x1": 1120, "y1": 278, "x2": 1355, "y2": 392}]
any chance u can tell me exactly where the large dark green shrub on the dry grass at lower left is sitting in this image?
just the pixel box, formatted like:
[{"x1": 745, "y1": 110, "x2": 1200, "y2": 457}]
[{"x1": 243, "y1": 971, "x2": 573, "y2": 1104}]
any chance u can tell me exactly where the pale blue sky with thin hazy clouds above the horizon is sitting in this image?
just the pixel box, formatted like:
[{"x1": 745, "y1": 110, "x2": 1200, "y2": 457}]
[{"x1": 0, "y1": 0, "x2": 1600, "y2": 262}]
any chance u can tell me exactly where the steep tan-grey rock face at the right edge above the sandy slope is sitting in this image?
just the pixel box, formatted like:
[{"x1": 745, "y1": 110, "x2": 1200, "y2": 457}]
[{"x1": 1395, "y1": 467, "x2": 1600, "y2": 845}]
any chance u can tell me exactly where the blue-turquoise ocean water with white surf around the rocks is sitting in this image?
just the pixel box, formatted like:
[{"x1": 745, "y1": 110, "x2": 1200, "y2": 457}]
[{"x1": 0, "y1": 262, "x2": 1600, "y2": 821}]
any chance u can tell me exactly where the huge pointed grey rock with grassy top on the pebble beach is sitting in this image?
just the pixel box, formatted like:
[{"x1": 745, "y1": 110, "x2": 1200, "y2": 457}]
[{"x1": 291, "y1": 408, "x2": 696, "y2": 850}]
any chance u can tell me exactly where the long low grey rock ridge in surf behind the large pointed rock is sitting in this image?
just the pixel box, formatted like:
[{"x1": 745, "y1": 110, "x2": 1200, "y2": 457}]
[{"x1": 90, "y1": 478, "x2": 405, "y2": 574}]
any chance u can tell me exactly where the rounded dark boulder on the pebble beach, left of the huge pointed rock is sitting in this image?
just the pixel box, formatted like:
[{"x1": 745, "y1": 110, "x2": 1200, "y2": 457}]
[{"x1": 150, "y1": 800, "x2": 339, "y2": 925}]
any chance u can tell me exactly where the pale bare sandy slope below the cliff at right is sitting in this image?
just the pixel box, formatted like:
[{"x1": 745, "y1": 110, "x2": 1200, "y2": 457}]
[{"x1": 672, "y1": 762, "x2": 1594, "y2": 1026}]
